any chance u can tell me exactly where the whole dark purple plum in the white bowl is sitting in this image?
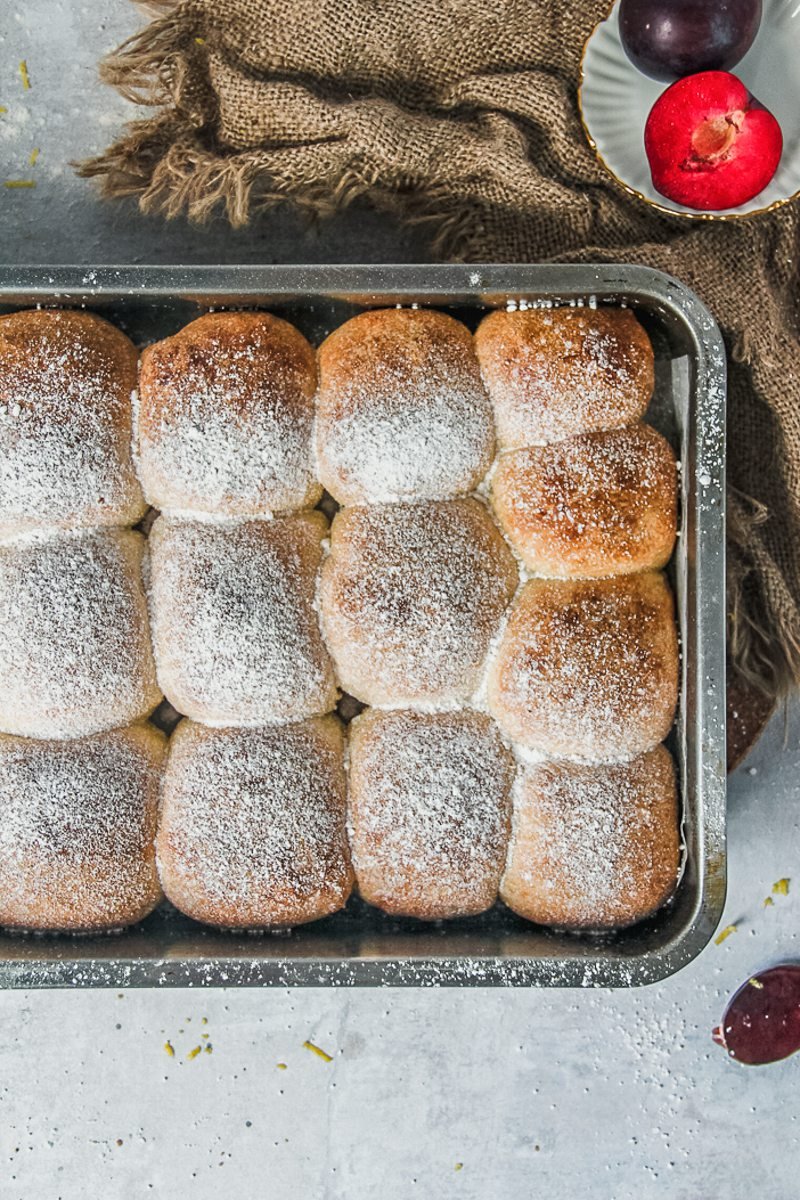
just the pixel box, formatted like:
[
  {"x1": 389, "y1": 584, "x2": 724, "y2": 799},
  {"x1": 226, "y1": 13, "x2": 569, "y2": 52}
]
[{"x1": 619, "y1": 0, "x2": 762, "y2": 80}]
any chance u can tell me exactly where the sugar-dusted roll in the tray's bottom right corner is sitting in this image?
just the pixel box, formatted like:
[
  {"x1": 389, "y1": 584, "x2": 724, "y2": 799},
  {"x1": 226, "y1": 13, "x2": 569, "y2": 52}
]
[{"x1": 500, "y1": 746, "x2": 680, "y2": 930}]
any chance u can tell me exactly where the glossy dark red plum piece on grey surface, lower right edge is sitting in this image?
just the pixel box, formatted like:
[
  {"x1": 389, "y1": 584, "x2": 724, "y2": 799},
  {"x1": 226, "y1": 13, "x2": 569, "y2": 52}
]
[{"x1": 711, "y1": 964, "x2": 800, "y2": 1066}]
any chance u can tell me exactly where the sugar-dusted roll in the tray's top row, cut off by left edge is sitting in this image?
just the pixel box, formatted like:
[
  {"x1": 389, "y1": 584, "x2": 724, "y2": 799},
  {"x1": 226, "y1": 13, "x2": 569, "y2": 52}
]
[{"x1": 0, "y1": 310, "x2": 146, "y2": 538}]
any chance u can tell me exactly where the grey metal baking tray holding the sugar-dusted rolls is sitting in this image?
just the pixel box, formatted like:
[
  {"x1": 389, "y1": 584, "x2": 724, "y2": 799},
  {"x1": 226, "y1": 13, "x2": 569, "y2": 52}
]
[{"x1": 0, "y1": 265, "x2": 726, "y2": 988}]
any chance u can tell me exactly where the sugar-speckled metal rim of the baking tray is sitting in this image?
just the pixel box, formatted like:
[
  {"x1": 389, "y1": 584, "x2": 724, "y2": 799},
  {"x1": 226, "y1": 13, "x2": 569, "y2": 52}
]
[{"x1": 0, "y1": 263, "x2": 726, "y2": 988}]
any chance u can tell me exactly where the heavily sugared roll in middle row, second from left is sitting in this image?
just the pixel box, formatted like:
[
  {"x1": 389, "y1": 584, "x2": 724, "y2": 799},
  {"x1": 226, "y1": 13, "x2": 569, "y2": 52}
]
[{"x1": 148, "y1": 512, "x2": 337, "y2": 725}]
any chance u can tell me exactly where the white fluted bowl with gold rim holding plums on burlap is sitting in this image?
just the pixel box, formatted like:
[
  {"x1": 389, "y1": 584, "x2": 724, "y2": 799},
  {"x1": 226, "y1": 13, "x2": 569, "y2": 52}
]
[{"x1": 578, "y1": 0, "x2": 800, "y2": 221}]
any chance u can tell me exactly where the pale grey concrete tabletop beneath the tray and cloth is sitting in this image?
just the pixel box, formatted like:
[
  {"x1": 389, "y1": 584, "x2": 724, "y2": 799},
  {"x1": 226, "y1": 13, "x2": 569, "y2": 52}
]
[{"x1": 0, "y1": 0, "x2": 800, "y2": 1200}]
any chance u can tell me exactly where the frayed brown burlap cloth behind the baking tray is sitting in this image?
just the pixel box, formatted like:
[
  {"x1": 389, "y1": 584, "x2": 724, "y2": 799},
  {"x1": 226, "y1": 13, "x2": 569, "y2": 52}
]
[{"x1": 82, "y1": 0, "x2": 800, "y2": 696}]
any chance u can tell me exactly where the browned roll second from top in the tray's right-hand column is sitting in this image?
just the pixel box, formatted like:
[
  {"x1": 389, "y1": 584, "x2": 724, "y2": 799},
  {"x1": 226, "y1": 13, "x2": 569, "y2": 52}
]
[{"x1": 492, "y1": 425, "x2": 678, "y2": 578}]
